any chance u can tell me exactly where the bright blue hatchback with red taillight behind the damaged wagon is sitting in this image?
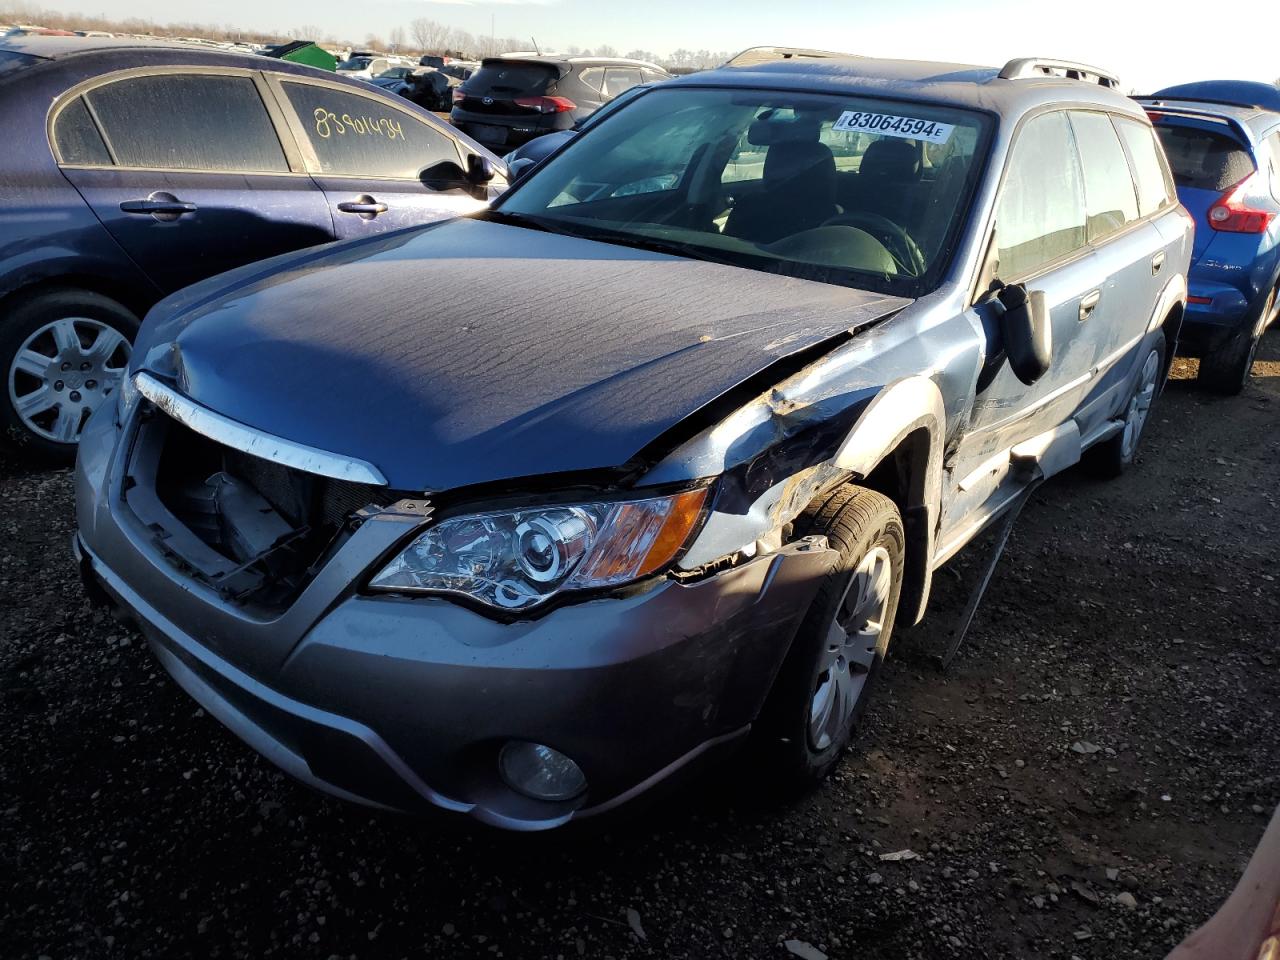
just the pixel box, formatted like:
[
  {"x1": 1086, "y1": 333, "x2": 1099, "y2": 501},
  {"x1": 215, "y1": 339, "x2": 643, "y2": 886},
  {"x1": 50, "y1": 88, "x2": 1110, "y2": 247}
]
[{"x1": 1140, "y1": 81, "x2": 1280, "y2": 393}]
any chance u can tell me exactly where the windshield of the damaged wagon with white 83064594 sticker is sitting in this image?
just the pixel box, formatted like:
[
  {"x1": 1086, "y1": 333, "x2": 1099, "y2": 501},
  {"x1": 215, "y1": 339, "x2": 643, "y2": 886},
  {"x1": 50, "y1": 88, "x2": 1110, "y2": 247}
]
[{"x1": 495, "y1": 88, "x2": 988, "y2": 296}]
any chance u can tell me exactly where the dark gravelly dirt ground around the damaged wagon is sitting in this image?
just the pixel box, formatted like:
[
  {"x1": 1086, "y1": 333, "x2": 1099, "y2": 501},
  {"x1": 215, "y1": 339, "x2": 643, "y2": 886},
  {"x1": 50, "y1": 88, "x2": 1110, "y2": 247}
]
[{"x1": 0, "y1": 333, "x2": 1280, "y2": 960}]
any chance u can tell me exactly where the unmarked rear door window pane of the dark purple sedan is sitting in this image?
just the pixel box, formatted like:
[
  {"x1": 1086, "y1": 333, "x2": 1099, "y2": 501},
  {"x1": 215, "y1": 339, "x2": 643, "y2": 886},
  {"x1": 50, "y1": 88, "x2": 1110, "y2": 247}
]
[{"x1": 84, "y1": 73, "x2": 289, "y2": 173}]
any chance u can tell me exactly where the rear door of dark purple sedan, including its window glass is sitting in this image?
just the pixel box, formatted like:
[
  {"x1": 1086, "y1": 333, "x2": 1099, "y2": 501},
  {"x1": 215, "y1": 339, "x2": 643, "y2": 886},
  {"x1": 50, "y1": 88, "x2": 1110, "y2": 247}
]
[{"x1": 51, "y1": 68, "x2": 333, "y2": 292}]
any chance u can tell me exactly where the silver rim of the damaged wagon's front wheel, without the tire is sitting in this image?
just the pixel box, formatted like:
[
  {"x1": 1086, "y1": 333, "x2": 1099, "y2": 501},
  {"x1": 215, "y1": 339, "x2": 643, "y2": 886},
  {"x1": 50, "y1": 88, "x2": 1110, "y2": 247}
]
[{"x1": 809, "y1": 547, "x2": 893, "y2": 750}]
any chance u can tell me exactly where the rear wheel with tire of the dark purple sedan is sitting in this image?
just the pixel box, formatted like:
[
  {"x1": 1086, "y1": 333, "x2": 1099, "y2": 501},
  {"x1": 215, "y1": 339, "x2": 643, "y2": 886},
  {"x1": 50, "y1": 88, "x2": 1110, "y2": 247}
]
[{"x1": 0, "y1": 291, "x2": 138, "y2": 463}]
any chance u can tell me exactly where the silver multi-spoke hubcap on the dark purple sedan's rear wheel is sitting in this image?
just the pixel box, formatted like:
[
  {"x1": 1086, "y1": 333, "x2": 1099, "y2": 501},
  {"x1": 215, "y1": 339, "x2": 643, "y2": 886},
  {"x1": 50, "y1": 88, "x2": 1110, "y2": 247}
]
[{"x1": 9, "y1": 316, "x2": 129, "y2": 443}]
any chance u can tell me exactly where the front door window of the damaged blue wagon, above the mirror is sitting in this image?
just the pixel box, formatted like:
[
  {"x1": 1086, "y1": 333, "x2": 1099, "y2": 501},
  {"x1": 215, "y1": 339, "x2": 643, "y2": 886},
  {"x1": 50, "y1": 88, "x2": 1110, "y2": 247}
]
[{"x1": 996, "y1": 113, "x2": 1088, "y2": 280}]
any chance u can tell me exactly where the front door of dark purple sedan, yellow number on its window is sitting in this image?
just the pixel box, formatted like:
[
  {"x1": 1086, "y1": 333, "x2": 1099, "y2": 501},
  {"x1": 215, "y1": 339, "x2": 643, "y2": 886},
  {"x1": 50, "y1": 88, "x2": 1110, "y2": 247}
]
[{"x1": 273, "y1": 77, "x2": 489, "y2": 239}]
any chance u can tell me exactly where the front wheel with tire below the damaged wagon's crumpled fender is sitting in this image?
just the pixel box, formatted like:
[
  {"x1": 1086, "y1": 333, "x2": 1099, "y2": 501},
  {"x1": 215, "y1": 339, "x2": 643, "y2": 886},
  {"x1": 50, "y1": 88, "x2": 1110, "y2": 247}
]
[{"x1": 755, "y1": 485, "x2": 906, "y2": 795}]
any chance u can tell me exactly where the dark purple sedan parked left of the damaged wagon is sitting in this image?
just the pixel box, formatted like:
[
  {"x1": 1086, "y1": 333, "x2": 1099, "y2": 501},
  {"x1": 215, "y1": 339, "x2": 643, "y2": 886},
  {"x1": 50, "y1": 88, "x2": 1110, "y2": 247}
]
[{"x1": 0, "y1": 37, "x2": 507, "y2": 461}]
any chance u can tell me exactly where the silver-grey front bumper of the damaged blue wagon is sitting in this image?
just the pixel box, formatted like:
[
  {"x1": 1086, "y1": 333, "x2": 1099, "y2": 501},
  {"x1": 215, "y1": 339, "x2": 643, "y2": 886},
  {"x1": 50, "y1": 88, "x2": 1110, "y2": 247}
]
[{"x1": 76, "y1": 412, "x2": 833, "y2": 829}]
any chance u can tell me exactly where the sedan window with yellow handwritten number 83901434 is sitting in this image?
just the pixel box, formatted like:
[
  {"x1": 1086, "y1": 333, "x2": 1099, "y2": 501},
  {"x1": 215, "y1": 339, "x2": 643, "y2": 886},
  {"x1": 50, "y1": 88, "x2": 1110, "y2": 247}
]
[{"x1": 283, "y1": 81, "x2": 460, "y2": 179}]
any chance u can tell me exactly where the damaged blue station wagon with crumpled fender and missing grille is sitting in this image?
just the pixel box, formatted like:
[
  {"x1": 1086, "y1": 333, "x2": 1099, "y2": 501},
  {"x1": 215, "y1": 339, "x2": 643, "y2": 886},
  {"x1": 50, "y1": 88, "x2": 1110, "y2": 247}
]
[{"x1": 77, "y1": 58, "x2": 1192, "y2": 829}]
